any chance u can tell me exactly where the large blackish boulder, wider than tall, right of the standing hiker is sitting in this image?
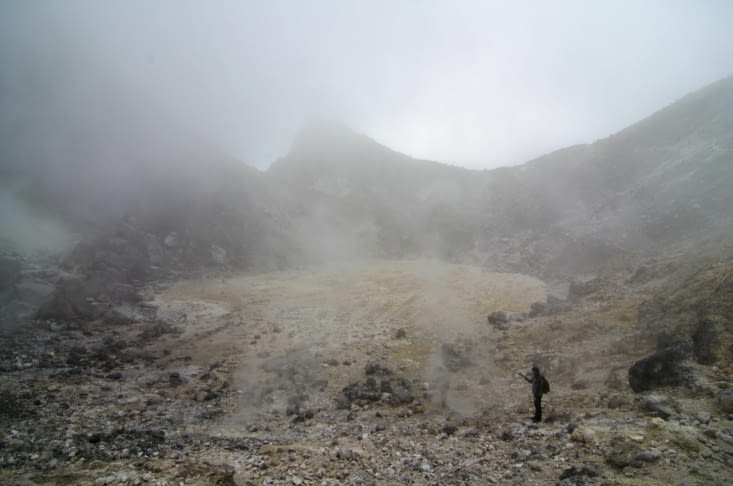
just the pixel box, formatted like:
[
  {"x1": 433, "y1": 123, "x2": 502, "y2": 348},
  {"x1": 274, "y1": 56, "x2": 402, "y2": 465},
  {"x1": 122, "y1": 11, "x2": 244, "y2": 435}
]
[{"x1": 629, "y1": 341, "x2": 692, "y2": 393}]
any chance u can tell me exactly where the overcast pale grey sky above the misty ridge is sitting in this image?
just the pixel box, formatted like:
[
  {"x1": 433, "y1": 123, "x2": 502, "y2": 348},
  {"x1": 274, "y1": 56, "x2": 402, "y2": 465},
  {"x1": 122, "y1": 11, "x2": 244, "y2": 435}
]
[{"x1": 0, "y1": 0, "x2": 733, "y2": 168}]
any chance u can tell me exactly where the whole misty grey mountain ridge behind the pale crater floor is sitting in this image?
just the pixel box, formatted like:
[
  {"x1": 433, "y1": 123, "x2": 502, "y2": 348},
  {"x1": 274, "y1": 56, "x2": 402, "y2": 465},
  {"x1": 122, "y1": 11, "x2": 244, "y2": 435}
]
[{"x1": 3, "y1": 77, "x2": 733, "y2": 274}]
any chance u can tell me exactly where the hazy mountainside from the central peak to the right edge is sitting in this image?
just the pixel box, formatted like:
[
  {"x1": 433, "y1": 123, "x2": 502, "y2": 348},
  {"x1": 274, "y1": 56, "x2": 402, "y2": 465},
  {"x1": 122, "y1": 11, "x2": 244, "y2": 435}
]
[{"x1": 267, "y1": 78, "x2": 733, "y2": 276}]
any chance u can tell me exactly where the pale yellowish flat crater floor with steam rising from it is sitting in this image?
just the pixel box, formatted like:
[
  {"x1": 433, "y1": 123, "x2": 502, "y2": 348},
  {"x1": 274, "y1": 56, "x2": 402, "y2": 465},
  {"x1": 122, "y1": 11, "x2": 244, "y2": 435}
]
[{"x1": 157, "y1": 261, "x2": 545, "y2": 430}]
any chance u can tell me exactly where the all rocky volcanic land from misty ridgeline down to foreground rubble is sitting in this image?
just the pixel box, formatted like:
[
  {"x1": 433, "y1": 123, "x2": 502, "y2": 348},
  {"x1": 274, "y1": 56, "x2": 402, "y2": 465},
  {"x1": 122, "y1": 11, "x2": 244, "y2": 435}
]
[{"x1": 0, "y1": 79, "x2": 733, "y2": 485}]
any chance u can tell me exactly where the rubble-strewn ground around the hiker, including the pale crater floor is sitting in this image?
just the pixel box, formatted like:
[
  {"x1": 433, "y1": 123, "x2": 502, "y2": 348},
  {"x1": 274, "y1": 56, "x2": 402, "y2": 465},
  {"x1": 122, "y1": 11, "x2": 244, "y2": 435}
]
[{"x1": 0, "y1": 260, "x2": 733, "y2": 485}]
